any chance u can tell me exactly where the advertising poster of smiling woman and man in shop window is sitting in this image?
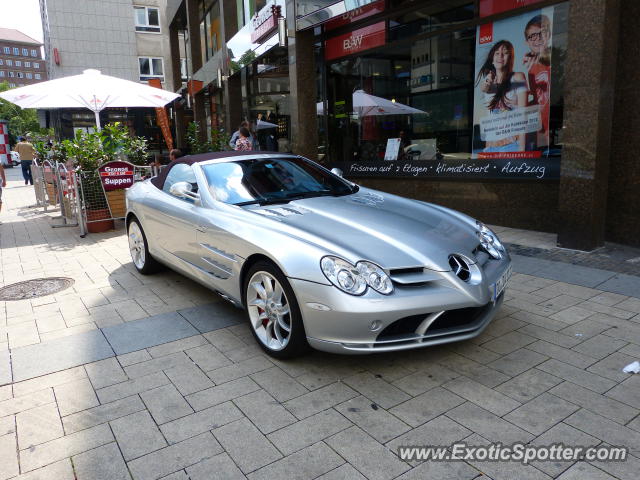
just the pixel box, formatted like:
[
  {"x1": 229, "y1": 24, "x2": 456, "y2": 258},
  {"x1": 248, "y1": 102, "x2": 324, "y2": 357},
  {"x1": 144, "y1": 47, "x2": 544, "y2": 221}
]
[{"x1": 472, "y1": 7, "x2": 554, "y2": 159}]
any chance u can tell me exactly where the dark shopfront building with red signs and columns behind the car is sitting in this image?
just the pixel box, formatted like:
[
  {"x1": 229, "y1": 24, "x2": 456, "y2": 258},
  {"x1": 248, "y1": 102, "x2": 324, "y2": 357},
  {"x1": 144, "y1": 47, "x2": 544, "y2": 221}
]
[{"x1": 167, "y1": 0, "x2": 640, "y2": 250}]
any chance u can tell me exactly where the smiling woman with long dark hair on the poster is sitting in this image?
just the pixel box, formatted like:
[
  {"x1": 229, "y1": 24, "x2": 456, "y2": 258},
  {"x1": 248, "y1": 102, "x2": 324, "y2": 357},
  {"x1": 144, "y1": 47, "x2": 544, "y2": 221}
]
[{"x1": 476, "y1": 40, "x2": 528, "y2": 152}]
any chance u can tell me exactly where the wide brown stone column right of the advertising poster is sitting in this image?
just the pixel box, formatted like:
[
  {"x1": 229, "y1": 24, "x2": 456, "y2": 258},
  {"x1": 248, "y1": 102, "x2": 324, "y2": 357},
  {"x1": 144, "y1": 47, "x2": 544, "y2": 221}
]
[{"x1": 558, "y1": 0, "x2": 620, "y2": 250}]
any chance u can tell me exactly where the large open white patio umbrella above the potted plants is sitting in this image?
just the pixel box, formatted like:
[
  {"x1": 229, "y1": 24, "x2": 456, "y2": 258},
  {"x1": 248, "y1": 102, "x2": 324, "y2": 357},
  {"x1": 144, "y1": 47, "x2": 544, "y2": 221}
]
[{"x1": 0, "y1": 70, "x2": 180, "y2": 130}]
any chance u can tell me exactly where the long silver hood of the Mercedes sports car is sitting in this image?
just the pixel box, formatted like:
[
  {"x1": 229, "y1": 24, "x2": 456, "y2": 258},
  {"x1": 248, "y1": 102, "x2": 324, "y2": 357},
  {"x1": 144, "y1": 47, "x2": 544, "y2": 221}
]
[{"x1": 251, "y1": 188, "x2": 479, "y2": 271}]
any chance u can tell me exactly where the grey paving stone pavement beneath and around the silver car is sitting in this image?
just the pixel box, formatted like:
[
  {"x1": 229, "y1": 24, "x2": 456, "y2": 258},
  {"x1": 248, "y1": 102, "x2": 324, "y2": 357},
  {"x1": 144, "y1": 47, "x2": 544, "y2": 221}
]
[{"x1": 0, "y1": 166, "x2": 640, "y2": 480}]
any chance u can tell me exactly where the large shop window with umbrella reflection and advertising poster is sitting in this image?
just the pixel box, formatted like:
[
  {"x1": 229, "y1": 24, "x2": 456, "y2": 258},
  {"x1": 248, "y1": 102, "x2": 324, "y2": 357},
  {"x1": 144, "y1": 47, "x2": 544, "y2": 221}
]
[{"x1": 317, "y1": 2, "x2": 568, "y2": 178}]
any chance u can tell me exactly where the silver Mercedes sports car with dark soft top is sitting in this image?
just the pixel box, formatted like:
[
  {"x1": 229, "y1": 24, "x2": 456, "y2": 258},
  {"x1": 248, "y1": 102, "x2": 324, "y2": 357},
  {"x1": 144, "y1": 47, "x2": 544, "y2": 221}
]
[{"x1": 127, "y1": 152, "x2": 511, "y2": 357}]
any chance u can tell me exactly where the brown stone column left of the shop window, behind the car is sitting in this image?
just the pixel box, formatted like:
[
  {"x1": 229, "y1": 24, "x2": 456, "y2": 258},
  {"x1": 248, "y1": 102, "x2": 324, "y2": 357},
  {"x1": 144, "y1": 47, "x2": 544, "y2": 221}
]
[{"x1": 287, "y1": 2, "x2": 318, "y2": 160}]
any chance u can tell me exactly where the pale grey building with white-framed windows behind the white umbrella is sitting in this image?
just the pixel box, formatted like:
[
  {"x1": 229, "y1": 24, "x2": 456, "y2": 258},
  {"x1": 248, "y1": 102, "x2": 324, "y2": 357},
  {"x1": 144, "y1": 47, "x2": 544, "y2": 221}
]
[{"x1": 40, "y1": 0, "x2": 175, "y2": 146}]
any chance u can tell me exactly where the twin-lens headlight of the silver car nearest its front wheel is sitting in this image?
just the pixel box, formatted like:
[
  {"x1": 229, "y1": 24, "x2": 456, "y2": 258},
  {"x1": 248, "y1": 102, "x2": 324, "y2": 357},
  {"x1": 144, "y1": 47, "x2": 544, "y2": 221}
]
[{"x1": 320, "y1": 256, "x2": 393, "y2": 295}]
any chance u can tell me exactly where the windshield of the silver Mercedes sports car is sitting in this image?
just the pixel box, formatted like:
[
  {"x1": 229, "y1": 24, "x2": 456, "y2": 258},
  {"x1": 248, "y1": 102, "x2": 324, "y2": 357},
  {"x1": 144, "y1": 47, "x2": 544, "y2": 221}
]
[{"x1": 203, "y1": 158, "x2": 358, "y2": 205}]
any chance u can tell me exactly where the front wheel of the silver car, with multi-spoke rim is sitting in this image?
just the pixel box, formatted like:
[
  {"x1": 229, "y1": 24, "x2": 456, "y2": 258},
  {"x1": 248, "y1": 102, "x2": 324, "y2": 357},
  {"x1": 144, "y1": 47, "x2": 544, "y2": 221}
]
[{"x1": 243, "y1": 261, "x2": 309, "y2": 358}]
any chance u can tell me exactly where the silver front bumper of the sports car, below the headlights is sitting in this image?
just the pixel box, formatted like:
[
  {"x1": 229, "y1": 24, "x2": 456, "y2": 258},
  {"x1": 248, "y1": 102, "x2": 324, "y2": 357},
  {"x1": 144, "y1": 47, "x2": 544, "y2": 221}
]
[{"x1": 289, "y1": 260, "x2": 510, "y2": 354}]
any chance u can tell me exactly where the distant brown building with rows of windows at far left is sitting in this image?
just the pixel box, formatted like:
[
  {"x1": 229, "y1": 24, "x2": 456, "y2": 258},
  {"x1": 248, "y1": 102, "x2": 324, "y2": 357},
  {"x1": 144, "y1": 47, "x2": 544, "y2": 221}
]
[{"x1": 0, "y1": 28, "x2": 47, "y2": 88}]
